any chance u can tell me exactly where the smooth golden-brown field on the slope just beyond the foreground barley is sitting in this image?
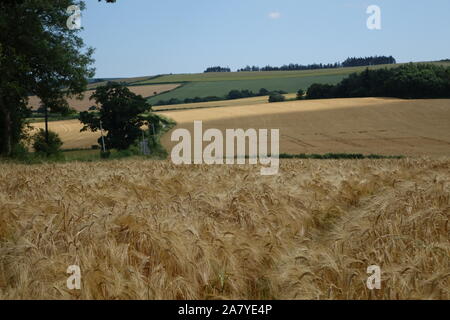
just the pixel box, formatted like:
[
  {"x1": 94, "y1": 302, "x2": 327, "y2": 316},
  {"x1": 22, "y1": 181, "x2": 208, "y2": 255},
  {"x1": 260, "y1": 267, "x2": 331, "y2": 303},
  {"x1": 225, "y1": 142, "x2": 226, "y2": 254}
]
[{"x1": 30, "y1": 98, "x2": 450, "y2": 156}]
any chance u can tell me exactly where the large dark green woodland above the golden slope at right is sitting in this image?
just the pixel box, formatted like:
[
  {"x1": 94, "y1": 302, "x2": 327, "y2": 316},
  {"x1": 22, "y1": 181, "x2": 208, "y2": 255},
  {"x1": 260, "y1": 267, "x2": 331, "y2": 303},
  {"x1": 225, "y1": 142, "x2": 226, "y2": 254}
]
[{"x1": 306, "y1": 63, "x2": 450, "y2": 99}]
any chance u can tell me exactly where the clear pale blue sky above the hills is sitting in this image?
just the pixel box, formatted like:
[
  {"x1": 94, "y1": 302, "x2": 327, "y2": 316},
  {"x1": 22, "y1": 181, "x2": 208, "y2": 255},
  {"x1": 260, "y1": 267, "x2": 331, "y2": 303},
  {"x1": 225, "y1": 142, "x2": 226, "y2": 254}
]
[{"x1": 81, "y1": 0, "x2": 450, "y2": 77}]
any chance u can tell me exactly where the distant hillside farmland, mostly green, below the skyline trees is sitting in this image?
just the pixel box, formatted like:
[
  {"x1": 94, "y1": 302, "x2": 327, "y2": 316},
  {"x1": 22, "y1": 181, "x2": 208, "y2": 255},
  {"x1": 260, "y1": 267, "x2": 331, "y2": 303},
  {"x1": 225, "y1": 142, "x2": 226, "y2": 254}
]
[{"x1": 23, "y1": 62, "x2": 450, "y2": 111}]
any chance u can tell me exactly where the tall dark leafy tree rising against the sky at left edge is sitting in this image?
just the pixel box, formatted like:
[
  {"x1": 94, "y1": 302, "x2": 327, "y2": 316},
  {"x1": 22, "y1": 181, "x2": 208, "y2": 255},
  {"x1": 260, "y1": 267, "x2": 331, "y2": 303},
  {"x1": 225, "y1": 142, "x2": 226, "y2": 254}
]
[{"x1": 0, "y1": 0, "x2": 96, "y2": 156}]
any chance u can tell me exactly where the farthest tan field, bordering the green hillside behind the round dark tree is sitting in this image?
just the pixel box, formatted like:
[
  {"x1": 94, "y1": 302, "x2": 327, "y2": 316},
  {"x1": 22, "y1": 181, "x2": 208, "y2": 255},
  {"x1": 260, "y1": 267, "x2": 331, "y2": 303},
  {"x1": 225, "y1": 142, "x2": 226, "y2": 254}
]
[{"x1": 28, "y1": 83, "x2": 180, "y2": 111}]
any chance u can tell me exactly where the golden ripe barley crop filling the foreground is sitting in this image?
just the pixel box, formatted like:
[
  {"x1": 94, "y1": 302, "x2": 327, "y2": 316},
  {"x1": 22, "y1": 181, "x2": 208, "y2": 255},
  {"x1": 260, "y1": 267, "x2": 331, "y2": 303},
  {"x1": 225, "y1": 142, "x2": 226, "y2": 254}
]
[{"x1": 0, "y1": 158, "x2": 450, "y2": 299}]
